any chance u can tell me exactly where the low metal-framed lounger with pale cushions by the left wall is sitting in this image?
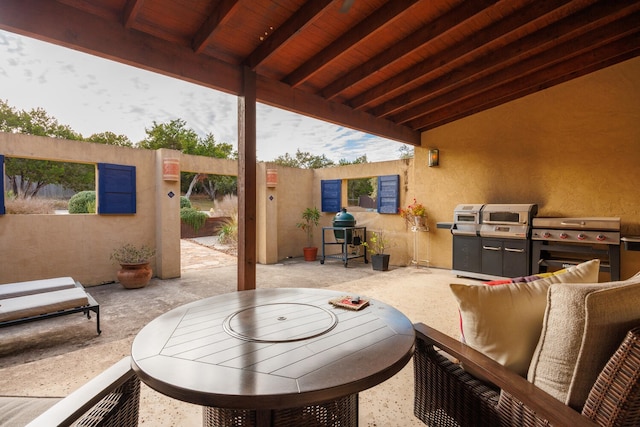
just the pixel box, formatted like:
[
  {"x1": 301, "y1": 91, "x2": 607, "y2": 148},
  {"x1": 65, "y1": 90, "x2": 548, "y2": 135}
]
[{"x1": 0, "y1": 277, "x2": 101, "y2": 334}]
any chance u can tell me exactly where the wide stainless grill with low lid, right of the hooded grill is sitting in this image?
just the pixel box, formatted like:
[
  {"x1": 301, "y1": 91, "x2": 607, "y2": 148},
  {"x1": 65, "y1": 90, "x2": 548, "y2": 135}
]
[{"x1": 531, "y1": 217, "x2": 620, "y2": 280}]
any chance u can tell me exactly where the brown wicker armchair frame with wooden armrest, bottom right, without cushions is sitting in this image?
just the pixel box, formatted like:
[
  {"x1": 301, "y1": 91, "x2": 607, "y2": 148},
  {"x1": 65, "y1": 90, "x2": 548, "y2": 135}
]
[{"x1": 414, "y1": 323, "x2": 640, "y2": 427}]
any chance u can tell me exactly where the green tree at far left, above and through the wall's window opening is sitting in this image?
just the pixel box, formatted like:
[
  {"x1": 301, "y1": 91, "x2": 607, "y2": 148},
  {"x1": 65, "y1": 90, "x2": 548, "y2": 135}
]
[{"x1": 0, "y1": 101, "x2": 95, "y2": 199}]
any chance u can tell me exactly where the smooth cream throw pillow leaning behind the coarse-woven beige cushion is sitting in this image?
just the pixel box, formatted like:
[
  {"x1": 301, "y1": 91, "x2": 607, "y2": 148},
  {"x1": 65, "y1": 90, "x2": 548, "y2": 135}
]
[{"x1": 450, "y1": 259, "x2": 600, "y2": 377}]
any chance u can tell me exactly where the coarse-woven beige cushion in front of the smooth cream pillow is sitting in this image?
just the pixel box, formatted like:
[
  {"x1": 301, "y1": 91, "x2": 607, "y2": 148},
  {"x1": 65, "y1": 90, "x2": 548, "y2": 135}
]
[{"x1": 527, "y1": 275, "x2": 640, "y2": 410}]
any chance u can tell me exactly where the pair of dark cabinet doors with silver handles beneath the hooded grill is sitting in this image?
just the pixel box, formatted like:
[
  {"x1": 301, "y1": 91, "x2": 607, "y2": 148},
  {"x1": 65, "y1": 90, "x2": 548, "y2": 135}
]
[{"x1": 481, "y1": 238, "x2": 531, "y2": 277}]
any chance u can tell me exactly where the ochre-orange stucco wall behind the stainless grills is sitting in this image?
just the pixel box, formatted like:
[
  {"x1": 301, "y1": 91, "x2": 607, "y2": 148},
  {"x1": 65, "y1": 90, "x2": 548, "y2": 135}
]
[{"x1": 415, "y1": 58, "x2": 640, "y2": 278}]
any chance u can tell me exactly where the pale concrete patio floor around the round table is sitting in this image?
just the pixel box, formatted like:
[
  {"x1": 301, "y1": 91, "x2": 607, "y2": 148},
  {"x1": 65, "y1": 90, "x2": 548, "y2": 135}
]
[{"x1": 0, "y1": 239, "x2": 477, "y2": 426}]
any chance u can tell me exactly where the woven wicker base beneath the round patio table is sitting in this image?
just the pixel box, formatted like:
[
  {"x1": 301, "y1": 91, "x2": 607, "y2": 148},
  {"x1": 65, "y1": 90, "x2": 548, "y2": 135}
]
[{"x1": 202, "y1": 393, "x2": 358, "y2": 427}]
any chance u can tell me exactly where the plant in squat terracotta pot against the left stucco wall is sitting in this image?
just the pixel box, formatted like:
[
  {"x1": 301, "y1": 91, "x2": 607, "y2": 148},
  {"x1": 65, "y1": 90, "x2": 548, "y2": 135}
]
[{"x1": 111, "y1": 243, "x2": 156, "y2": 289}]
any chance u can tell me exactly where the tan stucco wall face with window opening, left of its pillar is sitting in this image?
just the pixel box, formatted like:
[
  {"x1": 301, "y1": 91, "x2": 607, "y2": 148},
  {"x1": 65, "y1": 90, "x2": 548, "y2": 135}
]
[{"x1": 0, "y1": 133, "x2": 165, "y2": 285}]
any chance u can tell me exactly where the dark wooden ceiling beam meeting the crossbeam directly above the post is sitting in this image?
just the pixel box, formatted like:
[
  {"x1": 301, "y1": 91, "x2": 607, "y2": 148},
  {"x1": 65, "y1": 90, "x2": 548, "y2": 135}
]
[{"x1": 244, "y1": 0, "x2": 333, "y2": 70}]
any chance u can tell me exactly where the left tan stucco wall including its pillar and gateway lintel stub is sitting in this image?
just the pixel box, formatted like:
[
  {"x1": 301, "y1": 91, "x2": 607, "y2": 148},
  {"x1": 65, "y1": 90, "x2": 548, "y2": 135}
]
[{"x1": 0, "y1": 137, "x2": 237, "y2": 286}]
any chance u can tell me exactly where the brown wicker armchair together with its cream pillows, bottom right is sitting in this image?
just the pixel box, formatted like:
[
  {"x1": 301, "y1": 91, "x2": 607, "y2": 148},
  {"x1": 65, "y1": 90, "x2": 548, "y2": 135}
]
[{"x1": 414, "y1": 263, "x2": 640, "y2": 427}]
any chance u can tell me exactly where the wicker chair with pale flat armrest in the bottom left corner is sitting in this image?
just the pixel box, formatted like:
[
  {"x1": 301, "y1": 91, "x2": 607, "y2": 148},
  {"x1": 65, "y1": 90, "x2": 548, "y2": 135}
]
[{"x1": 0, "y1": 357, "x2": 140, "y2": 427}]
